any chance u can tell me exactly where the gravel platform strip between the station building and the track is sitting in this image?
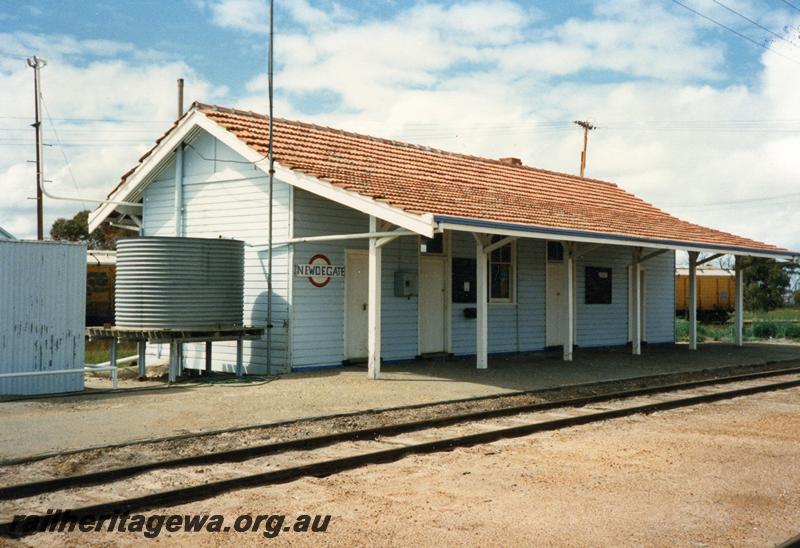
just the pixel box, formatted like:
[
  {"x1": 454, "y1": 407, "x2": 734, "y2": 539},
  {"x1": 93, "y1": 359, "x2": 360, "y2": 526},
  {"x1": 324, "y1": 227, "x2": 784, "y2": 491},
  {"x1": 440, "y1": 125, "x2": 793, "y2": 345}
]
[{"x1": 0, "y1": 343, "x2": 800, "y2": 460}]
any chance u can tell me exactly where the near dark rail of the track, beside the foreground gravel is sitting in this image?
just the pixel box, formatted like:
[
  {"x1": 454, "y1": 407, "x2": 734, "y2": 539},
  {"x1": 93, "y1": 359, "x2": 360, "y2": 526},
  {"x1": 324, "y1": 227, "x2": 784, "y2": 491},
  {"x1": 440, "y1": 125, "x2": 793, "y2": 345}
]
[{"x1": 0, "y1": 372, "x2": 800, "y2": 537}]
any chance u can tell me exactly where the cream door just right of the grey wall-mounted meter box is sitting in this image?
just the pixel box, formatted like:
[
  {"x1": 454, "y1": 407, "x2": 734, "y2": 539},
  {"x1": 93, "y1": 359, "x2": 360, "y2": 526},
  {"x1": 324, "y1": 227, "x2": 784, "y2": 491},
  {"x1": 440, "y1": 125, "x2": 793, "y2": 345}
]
[{"x1": 419, "y1": 255, "x2": 447, "y2": 354}]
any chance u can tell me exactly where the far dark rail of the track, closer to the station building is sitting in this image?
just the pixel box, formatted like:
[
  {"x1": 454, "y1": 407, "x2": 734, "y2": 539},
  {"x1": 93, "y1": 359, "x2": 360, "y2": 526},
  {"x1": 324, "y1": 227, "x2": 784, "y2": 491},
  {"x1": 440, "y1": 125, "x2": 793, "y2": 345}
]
[{"x1": 0, "y1": 368, "x2": 800, "y2": 500}]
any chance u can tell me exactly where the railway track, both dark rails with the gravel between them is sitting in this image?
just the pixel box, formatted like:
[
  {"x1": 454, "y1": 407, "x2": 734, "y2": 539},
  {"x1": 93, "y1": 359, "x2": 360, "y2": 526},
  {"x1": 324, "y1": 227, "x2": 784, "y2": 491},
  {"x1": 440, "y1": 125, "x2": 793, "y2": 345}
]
[{"x1": 0, "y1": 368, "x2": 800, "y2": 536}]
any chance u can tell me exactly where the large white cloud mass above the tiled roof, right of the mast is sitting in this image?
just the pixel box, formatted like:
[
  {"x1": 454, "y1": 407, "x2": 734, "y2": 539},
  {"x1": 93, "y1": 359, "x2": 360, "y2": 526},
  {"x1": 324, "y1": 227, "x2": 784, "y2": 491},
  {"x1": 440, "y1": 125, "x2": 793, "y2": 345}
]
[{"x1": 230, "y1": 0, "x2": 800, "y2": 249}]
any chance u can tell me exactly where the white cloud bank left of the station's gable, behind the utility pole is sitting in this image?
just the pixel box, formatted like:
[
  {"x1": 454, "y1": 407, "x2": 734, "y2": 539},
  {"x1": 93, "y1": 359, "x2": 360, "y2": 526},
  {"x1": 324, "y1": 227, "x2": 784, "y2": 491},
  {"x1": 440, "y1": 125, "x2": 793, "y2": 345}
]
[{"x1": 0, "y1": 33, "x2": 227, "y2": 237}]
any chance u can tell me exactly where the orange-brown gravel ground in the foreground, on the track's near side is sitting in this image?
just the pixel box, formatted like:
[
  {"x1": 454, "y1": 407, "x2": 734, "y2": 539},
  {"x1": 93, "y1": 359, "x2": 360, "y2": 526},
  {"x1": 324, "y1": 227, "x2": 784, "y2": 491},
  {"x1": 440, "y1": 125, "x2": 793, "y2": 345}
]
[{"x1": 10, "y1": 389, "x2": 800, "y2": 546}]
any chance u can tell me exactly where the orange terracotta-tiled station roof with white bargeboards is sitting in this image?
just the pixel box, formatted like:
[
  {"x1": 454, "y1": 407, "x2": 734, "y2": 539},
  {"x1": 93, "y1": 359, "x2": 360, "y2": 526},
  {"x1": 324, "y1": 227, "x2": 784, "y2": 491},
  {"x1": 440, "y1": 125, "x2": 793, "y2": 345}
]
[{"x1": 90, "y1": 103, "x2": 800, "y2": 258}]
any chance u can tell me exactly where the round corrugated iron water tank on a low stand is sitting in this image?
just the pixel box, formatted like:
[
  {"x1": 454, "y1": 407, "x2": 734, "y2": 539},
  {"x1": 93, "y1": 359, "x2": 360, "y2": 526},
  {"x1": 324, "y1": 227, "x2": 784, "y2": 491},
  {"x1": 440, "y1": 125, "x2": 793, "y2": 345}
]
[{"x1": 115, "y1": 237, "x2": 244, "y2": 329}]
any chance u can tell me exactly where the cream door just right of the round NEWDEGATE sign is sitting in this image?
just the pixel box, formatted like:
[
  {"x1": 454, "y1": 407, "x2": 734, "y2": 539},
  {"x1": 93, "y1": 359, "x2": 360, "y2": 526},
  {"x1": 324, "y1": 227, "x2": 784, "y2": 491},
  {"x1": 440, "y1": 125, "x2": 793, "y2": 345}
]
[{"x1": 344, "y1": 250, "x2": 369, "y2": 360}]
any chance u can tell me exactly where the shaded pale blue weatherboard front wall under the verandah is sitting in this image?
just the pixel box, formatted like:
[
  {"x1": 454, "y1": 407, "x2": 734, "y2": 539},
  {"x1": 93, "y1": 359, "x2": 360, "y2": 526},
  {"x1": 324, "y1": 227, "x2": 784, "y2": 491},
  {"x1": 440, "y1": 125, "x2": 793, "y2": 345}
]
[{"x1": 291, "y1": 197, "x2": 674, "y2": 368}]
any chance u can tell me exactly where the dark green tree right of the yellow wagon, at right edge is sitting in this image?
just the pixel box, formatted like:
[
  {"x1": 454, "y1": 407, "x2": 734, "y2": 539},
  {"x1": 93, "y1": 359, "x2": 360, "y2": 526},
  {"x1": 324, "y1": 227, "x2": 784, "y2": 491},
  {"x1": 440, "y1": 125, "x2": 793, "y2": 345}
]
[{"x1": 739, "y1": 257, "x2": 797, "y2": 310}]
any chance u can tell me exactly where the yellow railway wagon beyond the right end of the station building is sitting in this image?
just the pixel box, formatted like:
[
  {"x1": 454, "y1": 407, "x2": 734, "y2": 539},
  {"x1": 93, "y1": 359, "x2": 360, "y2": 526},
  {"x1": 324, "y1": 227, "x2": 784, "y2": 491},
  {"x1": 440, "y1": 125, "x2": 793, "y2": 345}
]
[{"x1": 675, "y1": 266, "x2": 736, "y2": 321}]
